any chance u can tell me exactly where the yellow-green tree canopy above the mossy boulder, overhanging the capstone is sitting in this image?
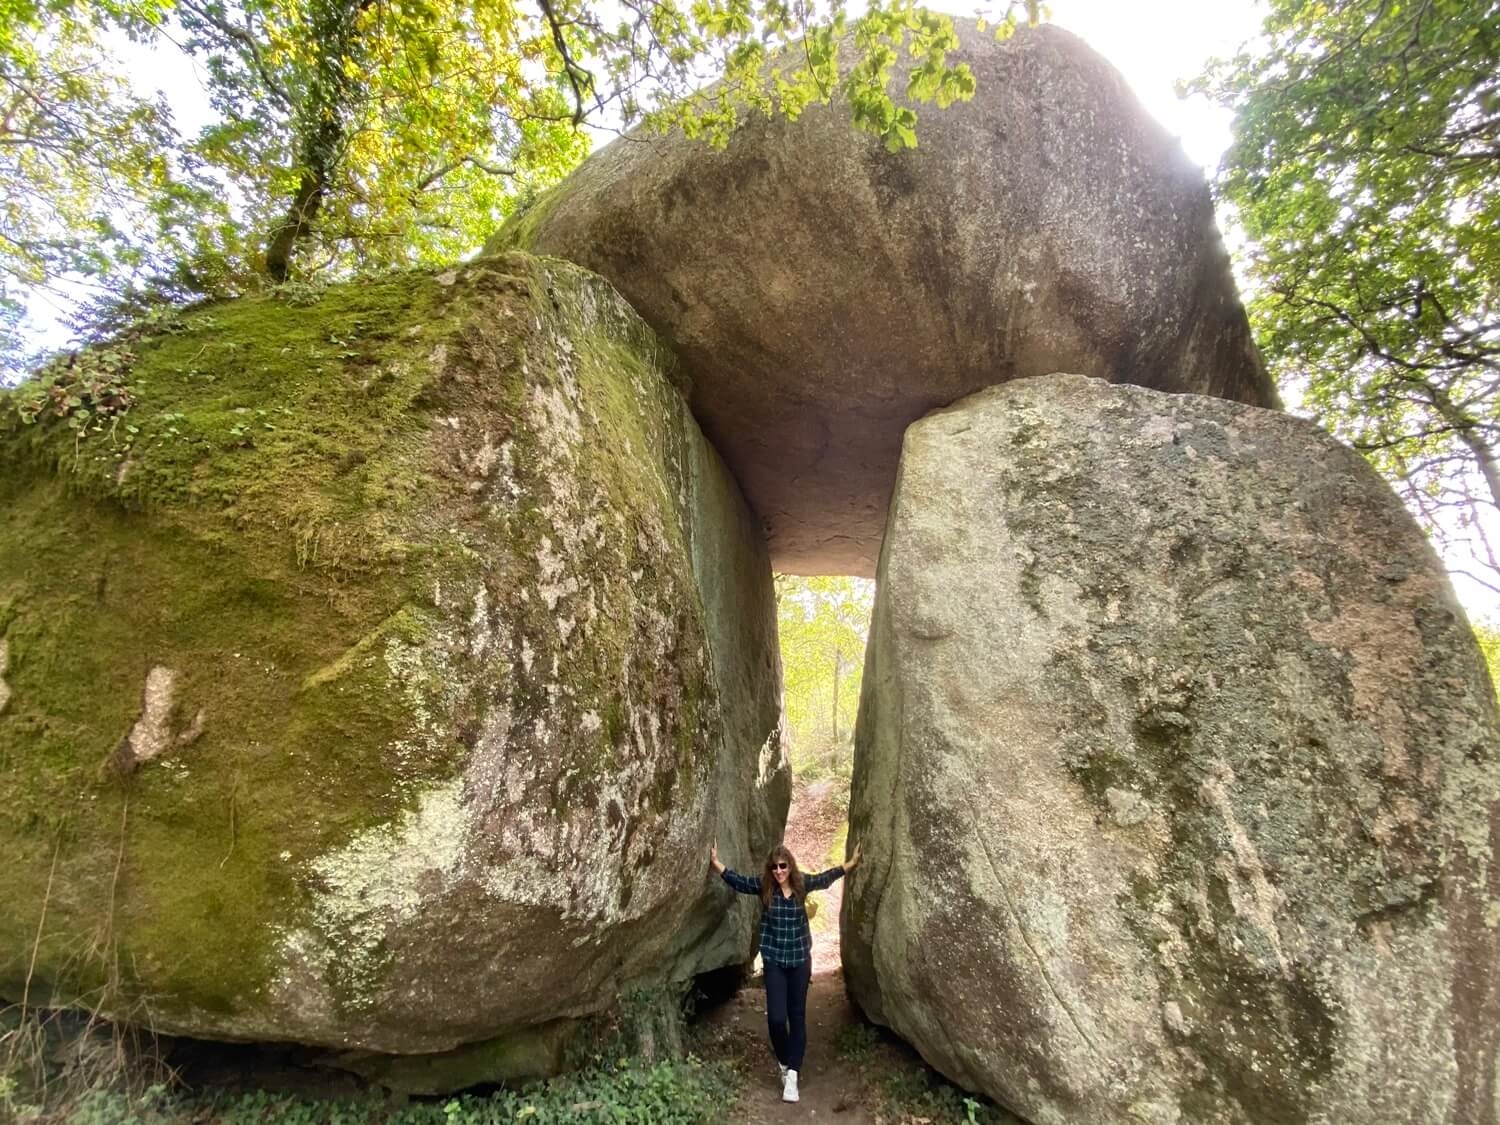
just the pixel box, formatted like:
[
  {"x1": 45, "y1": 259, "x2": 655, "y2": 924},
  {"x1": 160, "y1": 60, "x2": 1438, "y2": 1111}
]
[{"x1": 0, "y1": 0, "x2": 1041, "y2": 379}]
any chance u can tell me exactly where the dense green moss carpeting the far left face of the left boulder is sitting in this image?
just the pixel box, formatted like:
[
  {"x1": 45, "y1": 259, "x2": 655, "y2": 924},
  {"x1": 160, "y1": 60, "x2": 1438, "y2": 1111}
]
[{"x1": 0, "y1": 268, "x2": 483, "y2": 1010}]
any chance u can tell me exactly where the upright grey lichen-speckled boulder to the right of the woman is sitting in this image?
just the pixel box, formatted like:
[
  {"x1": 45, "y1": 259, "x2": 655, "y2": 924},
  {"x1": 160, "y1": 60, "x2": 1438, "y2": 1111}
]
[{"x1": 842, "y1": 375, "x2": 1500, "y2": 1125}]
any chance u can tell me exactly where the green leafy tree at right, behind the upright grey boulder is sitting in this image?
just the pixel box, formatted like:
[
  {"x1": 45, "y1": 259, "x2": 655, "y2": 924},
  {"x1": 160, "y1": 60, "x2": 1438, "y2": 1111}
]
[{"x1": 1194, "y1": 0, "x2": 1500, "y2": 593}]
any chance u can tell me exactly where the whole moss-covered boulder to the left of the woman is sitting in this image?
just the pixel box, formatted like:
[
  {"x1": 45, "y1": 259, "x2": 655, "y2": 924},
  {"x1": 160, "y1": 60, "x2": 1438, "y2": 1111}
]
[{"x1": 0, "y1": 255, "x2": 789, "y2": 1082}]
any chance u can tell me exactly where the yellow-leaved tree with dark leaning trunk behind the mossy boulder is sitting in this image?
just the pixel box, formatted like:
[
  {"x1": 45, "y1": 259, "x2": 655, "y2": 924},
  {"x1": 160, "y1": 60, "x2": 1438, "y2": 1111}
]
[{"x1": 176, "y1": 0, "x2": 588, "y2": 284}]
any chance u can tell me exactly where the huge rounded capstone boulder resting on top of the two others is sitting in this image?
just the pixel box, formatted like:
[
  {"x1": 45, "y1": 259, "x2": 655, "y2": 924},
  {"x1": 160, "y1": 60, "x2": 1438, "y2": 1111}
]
[{"x1": 491, "y1": 20, "x2": 1275, "y2": 576}]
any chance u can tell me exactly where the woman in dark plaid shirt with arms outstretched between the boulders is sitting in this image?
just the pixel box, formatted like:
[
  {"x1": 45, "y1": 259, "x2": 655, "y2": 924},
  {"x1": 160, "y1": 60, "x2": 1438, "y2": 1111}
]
[{"x1": 708, "y1": 842, "x2": 860, "y2": 1101}]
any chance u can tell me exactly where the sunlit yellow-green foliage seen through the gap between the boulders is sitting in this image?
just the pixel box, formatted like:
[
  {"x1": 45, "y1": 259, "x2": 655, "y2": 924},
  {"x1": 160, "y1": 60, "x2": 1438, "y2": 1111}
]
[{"x1": 776, "y1": 575, "x2": 875, "y2": 774}]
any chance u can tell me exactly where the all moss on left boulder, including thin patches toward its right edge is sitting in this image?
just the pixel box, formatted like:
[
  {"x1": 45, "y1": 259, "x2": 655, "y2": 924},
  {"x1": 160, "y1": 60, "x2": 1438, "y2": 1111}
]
[{"x1": 0, "y1": 255, "x2": 717, "y2": 1044}]
